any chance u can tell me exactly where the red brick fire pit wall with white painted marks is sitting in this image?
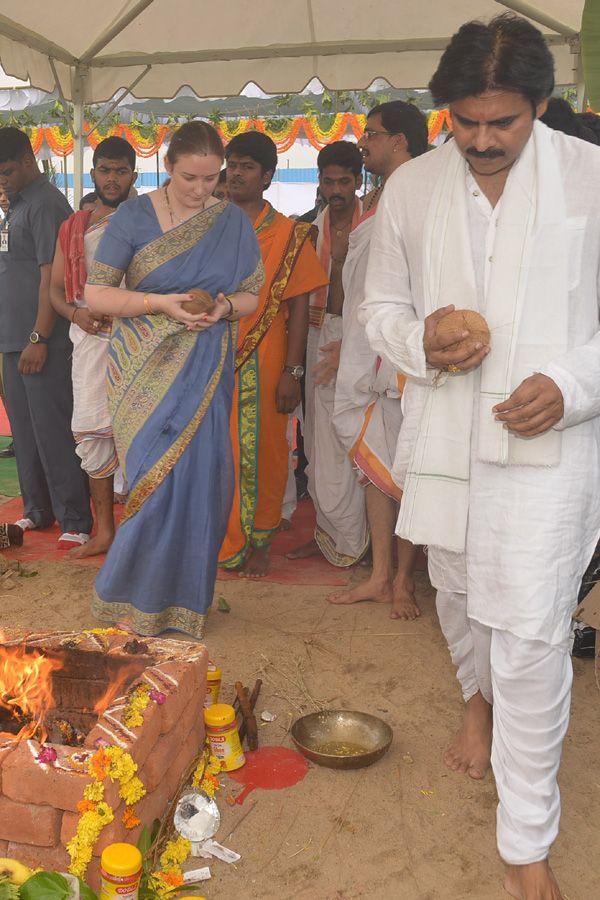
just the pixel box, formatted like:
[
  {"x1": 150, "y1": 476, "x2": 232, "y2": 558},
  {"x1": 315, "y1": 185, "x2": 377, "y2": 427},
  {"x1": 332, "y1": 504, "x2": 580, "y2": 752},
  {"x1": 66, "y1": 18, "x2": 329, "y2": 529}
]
[{"x1": 0, "y1": 634, "x2": 208, "y2": 883}]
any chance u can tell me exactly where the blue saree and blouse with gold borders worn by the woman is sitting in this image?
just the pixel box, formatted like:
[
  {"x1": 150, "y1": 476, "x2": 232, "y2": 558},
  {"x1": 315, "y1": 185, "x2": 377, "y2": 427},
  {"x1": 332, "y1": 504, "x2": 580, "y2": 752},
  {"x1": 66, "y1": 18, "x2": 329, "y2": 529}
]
[{"x1": 88, "y1": 196, "x2": 262, "y2": 638}]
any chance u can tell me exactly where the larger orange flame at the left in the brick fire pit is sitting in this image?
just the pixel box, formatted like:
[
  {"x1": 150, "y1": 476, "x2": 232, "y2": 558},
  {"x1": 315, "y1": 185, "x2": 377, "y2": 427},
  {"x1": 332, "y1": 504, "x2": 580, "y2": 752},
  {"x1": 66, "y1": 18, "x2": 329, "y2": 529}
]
[{"x1": 0, "y1": 646, "x2": 62, "y2": 742}]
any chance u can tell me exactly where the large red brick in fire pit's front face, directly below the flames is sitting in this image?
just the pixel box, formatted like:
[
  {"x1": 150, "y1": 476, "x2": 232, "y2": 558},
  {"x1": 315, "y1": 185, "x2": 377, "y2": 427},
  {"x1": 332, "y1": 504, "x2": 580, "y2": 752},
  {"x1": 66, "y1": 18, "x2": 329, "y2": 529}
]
[{"x1": 2, "y1": 741, "x2": 90, "y2": 811}]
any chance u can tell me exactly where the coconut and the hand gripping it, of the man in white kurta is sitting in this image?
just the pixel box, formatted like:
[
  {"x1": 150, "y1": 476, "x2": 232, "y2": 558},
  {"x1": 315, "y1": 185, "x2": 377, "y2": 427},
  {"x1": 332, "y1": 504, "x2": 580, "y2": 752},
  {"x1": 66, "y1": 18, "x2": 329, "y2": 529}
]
[{"x1": 423, "y1": 305, "x2": 490, "y2": 374}]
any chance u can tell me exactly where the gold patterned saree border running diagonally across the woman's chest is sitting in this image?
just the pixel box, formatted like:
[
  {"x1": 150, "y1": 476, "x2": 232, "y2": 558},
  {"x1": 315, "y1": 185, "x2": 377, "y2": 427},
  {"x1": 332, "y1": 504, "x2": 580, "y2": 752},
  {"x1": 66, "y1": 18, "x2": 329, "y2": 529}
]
[{"x1": 127, "y1": 200, "x2": 229, "y2": 291}]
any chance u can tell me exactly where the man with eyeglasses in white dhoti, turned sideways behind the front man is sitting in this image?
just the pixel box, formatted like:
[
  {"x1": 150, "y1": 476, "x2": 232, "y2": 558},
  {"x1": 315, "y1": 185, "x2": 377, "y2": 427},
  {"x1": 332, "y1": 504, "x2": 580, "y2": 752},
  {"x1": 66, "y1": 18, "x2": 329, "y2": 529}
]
[{"x1": 329, "y1": 100, "x2": 428, "y2": 619}]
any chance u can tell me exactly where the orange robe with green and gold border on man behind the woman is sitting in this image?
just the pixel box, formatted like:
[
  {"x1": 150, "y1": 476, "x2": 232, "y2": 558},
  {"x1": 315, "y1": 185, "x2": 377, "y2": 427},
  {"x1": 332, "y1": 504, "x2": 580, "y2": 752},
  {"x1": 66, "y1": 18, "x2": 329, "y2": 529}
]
[{"x1": 219, "y1": 203, "x2": 327, "y2": 569}]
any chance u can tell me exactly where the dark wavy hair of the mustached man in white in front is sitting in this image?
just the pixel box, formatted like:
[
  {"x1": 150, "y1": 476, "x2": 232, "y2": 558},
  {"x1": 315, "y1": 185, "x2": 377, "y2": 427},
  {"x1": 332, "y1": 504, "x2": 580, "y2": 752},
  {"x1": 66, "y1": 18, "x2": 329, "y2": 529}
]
[{"x1": 429, "y1": 13, "x2": 554, "y2": 110}]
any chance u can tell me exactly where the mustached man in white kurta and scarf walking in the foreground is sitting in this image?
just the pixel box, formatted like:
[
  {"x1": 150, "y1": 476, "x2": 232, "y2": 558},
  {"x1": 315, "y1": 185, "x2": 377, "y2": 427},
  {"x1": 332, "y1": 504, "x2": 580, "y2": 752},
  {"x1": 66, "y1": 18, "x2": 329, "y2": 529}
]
[{"x1": 360, "y1": 15, "x2": 600, "y2": 900}]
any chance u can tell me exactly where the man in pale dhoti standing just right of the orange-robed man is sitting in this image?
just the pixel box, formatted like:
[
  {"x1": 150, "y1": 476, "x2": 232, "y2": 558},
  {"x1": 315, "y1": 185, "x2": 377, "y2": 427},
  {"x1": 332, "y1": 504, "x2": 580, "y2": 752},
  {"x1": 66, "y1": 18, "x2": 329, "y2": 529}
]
[{"x1": 288, "y1": 141, "x2": 369, "y2": 566}]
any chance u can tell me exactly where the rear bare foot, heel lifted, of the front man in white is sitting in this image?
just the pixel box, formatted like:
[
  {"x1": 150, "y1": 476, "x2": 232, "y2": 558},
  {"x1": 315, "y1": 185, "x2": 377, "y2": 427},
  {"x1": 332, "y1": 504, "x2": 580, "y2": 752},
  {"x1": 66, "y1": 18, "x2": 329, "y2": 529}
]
[{"x1": 444, "y1": 691, "x2": 492, "y2": 780}]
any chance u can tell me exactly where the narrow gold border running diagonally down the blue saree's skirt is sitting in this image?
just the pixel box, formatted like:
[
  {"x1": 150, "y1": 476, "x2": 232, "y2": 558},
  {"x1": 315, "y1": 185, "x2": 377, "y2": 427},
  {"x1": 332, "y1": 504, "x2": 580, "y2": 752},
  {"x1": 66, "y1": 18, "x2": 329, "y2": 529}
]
[{"x1": 121, "y1": 328, "x2": 230, "y2": 526}]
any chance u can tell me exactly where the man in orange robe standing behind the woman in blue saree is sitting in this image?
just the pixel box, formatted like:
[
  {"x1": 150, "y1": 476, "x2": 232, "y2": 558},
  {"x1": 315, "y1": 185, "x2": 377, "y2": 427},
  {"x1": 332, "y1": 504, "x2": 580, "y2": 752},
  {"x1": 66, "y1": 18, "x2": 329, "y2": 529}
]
[{"x1": 220, "y1": 132, "x2": 328, "y2": 578}]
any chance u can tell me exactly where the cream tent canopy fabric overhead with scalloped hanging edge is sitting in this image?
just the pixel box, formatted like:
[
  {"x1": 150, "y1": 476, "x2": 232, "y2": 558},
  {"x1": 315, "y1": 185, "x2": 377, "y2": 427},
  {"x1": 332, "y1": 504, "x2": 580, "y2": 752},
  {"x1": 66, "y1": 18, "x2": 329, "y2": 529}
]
[{"x1": 0, "y1": 0, "x2": 584, "y2": 102}]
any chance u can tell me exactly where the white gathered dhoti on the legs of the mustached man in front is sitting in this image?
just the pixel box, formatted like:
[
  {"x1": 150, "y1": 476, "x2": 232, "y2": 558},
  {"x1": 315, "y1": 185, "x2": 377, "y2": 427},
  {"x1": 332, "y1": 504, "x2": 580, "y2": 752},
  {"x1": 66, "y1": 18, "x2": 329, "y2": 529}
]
[{"x1": 436, "y1": 591, "x2": 573, "y2": 866}]
